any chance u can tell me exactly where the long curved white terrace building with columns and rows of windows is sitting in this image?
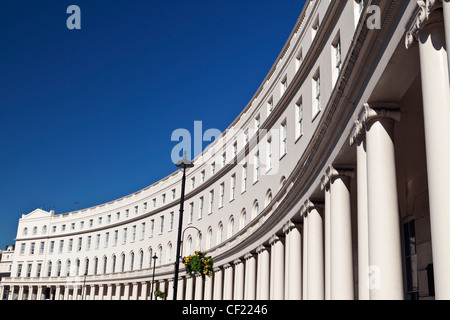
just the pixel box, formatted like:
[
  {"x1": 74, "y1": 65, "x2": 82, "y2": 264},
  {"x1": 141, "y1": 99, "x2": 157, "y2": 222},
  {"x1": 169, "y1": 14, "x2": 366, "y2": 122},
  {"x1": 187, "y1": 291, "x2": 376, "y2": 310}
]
[{"x1": 0, "y1": 0, "x2": 450, "y2": 300}]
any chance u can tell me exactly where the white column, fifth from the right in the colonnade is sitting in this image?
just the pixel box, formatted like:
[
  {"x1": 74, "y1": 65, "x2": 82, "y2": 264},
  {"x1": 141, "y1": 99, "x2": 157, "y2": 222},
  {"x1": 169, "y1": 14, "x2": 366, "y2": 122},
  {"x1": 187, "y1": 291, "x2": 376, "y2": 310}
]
[{"x1": 285, "y1": 221, "x2": 302, "y2": 300}]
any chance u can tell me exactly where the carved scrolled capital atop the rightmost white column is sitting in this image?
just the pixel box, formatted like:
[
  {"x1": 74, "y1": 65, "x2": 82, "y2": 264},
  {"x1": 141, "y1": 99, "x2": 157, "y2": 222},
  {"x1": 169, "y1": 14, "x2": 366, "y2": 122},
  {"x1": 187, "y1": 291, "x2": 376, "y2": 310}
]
[{"x1": 405, "y1": 0, "x2": 443, "y2": 49}]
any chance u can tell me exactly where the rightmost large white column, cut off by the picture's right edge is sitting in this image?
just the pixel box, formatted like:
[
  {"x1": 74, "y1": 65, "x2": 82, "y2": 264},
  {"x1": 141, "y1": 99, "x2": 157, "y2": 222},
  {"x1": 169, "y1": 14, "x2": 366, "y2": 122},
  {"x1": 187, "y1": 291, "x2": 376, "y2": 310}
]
[{"x1": 419, "y1": 7, "x2": 450, "y2": 300}]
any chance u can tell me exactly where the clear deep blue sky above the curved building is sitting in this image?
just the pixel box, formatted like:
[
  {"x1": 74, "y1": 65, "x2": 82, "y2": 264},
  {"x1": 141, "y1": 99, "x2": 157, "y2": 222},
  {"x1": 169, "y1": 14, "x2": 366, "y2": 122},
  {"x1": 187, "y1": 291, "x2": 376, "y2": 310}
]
[{"x1": 0, "y1": 0, "x2": 305, "y2": 249}]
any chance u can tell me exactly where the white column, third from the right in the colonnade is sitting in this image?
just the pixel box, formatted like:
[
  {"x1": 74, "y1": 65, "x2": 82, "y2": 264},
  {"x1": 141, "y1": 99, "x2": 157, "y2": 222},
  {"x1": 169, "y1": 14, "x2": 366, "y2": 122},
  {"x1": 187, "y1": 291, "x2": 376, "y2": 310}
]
[{"x1": 327, "y1": 166, "x2": 354, "y2": 300}]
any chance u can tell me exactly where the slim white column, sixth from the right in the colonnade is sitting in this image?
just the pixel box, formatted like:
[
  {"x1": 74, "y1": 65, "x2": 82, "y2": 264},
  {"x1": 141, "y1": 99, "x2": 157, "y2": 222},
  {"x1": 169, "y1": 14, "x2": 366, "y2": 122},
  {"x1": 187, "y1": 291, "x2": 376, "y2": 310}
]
[{"x1": 270, "y1": 235, "x2": 284, "y2": 300}]
